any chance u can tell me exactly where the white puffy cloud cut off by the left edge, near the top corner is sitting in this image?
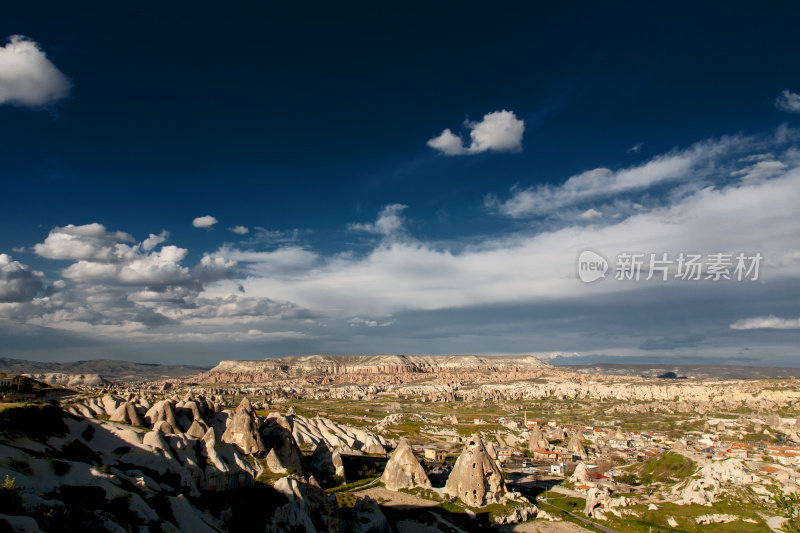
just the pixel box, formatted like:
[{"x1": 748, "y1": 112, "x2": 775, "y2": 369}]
[{"x1": 0, "y1": 35, "x2": 71, "y2": 107}]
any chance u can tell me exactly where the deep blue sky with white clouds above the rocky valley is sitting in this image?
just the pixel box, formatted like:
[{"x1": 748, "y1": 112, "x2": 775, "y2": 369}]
[{"x1": 0, "y1": 2, "x2": 800, "y2": 366}]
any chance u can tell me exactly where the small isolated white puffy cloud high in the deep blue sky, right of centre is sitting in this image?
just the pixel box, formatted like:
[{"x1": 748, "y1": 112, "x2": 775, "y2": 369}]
[{"x1": 427, "y1": 110, "x2": 525, "y2": 155}]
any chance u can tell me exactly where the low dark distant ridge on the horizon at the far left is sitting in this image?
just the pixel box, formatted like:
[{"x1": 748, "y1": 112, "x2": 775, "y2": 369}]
[{"x1": 0, "y1": 357, "x2": 208, "y2": 384}]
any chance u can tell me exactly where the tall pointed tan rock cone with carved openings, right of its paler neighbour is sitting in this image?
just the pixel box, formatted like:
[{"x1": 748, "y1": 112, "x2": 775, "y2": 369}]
[{"x1": 445, "y1": 434, "x2": 506, "y2": 507}]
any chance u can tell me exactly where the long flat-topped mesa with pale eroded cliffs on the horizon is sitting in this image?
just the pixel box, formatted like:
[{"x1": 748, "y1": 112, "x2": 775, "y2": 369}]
[{"x1": 194, "y1": 355, "x2": 552, "y2": 385}]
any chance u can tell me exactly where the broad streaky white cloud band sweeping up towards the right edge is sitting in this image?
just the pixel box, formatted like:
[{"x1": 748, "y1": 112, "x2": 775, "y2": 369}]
[{"x1": 211, "y1": 132, "x2": 800, "y2": 320}]
